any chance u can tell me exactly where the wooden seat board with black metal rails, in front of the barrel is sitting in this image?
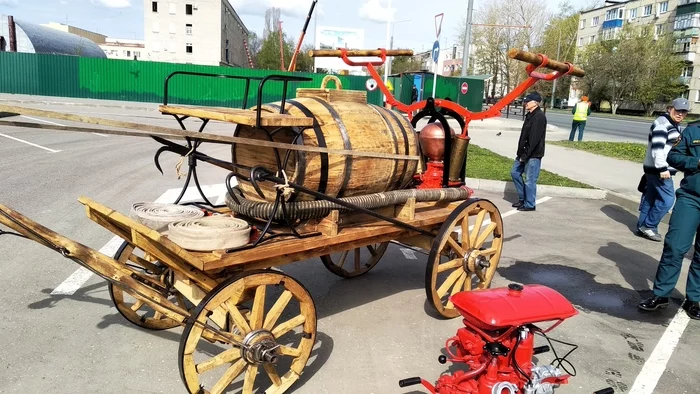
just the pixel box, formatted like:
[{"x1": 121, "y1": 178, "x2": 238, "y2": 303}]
[{"x1": 158, "y1": 105, "x2": 314, "y2": 127}]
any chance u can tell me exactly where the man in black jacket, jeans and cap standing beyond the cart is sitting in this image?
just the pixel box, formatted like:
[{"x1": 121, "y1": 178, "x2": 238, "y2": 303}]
[{"x1": 510, "y1": 92, "x2": 547, "y2": 211}]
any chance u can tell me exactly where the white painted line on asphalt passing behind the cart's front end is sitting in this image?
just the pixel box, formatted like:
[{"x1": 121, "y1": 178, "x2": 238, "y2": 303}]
[{"x1": 51, "y1": 183, "x2": 227, "y2": 295}]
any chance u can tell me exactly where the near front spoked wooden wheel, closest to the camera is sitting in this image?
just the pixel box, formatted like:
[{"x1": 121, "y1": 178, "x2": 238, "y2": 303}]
[{"x1": 179, "y1": 271, "x2": 316, "y2": 394}]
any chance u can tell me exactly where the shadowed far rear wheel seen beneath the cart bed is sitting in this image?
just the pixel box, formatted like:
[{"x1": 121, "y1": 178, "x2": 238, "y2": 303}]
[{"x1": 321, "y1": 242, "x2": 389, "y2": 278}]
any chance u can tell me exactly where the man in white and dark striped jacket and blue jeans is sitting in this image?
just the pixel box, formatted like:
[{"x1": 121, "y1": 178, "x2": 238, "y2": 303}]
[{"x1": 637, "y1": 97, "x2": 690, "y2": 242}]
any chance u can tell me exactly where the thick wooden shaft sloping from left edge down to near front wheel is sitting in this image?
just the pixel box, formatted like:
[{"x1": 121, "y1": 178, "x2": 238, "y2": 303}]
[{"x1": 0, "y1": 204, "x2": 189, "y2": 323}]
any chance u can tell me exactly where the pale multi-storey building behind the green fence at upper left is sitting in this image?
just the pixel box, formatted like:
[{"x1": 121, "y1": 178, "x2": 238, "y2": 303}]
[{"x1": 144, "y1": 0, "x2": 250, "y2": 68}]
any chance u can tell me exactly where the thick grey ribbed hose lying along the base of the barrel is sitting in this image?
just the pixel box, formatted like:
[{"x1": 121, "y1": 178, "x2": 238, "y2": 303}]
[{"x1": 226, "y1": 187, "x2": 471, "y2": 220}]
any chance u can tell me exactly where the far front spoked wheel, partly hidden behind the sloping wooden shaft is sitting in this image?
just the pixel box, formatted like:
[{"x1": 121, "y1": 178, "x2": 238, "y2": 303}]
[{"x1": 107, "y1": 242, "x2": 193, "y2": 330}]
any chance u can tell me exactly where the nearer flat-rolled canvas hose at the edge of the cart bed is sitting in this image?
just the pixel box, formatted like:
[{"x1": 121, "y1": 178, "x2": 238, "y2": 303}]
[{"x1": 168, "y1": 215, "x2": 250, "y2": 252}]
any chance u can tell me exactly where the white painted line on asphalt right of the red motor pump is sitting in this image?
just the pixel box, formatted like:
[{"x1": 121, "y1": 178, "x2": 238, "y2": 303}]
[{"x1": 630, "y1": 308, "x2": 690, "y2": 394}]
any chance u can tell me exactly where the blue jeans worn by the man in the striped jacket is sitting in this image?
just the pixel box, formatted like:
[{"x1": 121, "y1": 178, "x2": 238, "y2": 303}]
[{"x1": 637, "y1": 174, "x2": 676, "y2": 233}]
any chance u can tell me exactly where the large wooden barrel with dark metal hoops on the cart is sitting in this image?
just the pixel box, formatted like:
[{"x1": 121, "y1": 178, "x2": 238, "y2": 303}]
[{"x1": 232, "y1": 95, "x2": 418, "y2": 201}]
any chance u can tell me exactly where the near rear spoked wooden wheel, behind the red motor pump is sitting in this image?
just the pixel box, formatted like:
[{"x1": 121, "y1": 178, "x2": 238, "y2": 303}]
[{"x1": 425, "y1": 199, "x2": 503, "y2": 318}]
